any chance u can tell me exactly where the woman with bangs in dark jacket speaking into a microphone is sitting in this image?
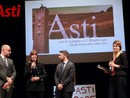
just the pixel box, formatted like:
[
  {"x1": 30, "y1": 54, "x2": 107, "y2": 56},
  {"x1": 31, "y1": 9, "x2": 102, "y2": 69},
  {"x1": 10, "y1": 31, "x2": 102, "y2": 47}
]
[{"x1": 24, "y1": 50, "x2": 47, "y2": 98}]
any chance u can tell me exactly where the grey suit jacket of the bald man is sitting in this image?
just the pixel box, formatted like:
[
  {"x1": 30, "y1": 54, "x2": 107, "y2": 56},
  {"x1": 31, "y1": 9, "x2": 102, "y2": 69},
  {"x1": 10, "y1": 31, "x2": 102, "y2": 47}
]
[{"x1": 0, "y1": 56, "x2": 16, "y2": 88}]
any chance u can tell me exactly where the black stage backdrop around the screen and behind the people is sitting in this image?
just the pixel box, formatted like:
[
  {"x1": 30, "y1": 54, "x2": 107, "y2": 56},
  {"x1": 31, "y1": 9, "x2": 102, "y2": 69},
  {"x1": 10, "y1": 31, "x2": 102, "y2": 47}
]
[{"x1": 0, "y1": 0, "x2": 130, "y2": 98}]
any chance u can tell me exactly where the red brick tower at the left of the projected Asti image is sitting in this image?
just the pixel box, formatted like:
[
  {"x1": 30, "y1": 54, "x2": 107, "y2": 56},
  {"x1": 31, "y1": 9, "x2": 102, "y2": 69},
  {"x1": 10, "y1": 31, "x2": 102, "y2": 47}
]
[{"x1": 32, "y1": 5, "x2": 49, "y2": 53}]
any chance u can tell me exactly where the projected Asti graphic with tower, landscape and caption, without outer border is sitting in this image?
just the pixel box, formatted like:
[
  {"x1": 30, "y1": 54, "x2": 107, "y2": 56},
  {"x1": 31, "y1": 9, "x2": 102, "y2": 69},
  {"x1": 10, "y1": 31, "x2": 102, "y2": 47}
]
[{"x1": 33, "y1": 5, "x2": 114, "y2": 54}]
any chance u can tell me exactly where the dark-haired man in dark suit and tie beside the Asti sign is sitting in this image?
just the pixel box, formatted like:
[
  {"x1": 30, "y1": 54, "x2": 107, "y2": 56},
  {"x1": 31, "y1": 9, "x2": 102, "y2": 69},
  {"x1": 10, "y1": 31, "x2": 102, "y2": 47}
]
[{"x1": 54, "y1": 50, "x2": 75, "y2": 98}]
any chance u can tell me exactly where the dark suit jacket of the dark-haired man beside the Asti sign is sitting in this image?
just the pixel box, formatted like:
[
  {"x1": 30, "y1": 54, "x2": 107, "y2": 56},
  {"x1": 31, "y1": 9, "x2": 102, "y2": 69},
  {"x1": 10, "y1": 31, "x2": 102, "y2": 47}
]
[{"x1": 54, "y1": 61, "x2": 75, "y2": 92}]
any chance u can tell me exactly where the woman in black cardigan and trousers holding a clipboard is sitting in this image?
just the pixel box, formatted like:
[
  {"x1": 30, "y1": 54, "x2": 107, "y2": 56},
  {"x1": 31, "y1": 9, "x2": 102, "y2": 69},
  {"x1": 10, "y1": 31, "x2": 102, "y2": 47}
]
[{"x1": 108, "y1": 40, "x2": 128, "y2": 98}]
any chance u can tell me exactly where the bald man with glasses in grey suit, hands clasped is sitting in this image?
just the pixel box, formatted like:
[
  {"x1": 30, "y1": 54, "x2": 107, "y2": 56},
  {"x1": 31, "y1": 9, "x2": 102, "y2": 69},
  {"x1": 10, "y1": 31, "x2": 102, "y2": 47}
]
[{"x1": 0, "y1": 44, "x2": 16, "y2": 98}]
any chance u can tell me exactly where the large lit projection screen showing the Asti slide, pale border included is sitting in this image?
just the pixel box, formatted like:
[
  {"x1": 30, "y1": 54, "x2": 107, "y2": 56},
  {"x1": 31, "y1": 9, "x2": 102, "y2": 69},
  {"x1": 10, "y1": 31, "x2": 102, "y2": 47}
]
[{"x1": 25, "y1": 0, "x2": 125, "y2": 64}]
